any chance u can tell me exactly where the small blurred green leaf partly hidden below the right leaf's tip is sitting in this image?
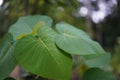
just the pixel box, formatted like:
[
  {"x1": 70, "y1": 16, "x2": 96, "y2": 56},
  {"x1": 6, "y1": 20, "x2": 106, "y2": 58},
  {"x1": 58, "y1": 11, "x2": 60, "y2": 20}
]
[{"x1": 83, "y1": 53, "x2": 111, "y2": 68}]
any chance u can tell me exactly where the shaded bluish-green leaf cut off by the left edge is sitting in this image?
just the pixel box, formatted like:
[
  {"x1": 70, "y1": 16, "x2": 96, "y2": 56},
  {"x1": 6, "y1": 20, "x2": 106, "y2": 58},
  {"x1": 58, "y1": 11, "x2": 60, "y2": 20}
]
[{"x1": 0, "y1": 34, "x2": 16, "y2": 80}]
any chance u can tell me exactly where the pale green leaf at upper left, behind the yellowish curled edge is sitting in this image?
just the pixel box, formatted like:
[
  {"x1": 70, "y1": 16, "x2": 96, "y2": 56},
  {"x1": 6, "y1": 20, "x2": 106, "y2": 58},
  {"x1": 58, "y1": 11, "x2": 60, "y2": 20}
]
[{"x1": 9, "y1": 15, "x2": 52, "y2": 40}]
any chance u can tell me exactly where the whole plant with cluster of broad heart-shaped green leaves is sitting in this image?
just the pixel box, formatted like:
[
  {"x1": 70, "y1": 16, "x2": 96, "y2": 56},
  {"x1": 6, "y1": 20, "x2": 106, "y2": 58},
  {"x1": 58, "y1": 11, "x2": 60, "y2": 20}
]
[{"x1": 0, "y1": 15, "x2": 114, "y2": 80}]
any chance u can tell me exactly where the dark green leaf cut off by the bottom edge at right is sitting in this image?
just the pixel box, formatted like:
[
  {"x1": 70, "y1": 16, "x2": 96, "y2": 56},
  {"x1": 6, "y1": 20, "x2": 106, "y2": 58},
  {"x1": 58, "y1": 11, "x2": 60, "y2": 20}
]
[{"x1": 83, "y1": 68, "x2": 116, "y2": 80}]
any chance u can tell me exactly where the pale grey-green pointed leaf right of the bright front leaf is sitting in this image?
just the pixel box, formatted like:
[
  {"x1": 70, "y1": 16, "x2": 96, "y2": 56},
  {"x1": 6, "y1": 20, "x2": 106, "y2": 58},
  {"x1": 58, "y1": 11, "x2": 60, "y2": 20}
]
[{"x1": 55, "y1": 23, "x2": 105, "y2": 55}]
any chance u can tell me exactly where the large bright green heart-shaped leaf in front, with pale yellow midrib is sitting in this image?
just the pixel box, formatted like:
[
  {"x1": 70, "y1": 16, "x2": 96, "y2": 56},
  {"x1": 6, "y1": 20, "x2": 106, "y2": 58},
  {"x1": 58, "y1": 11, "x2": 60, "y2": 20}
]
[{"x1": 14, "y1": 27, "x2": 72, "y2": 80}]
